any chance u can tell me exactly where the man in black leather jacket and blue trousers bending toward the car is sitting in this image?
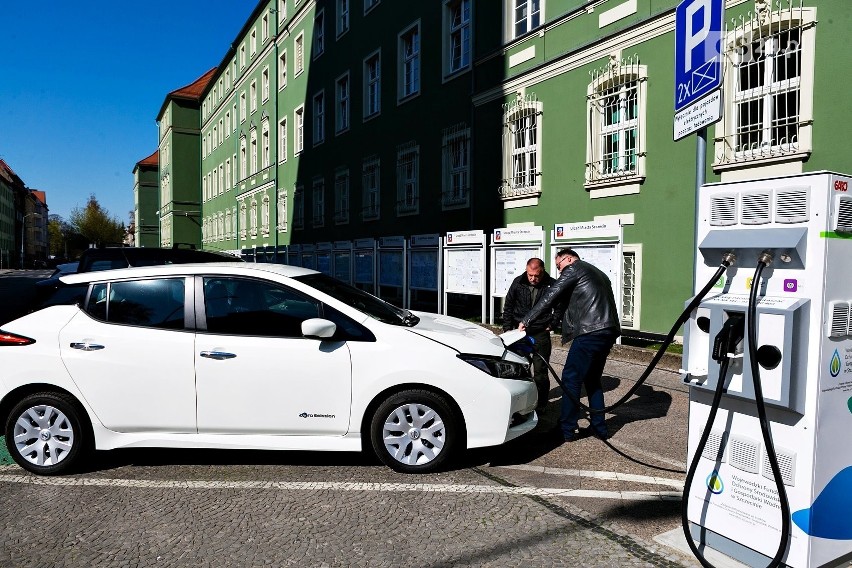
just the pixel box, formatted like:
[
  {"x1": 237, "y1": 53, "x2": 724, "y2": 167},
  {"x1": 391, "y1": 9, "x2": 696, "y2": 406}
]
[{"x1": 518, "y1": 248, "x2": 621, "y2": 442}]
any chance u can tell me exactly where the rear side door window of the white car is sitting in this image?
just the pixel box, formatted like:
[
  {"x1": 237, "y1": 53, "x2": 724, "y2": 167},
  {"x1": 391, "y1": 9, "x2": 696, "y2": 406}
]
[{"x1": 86, "y1": 278, "x2": 184, "y2": 329}]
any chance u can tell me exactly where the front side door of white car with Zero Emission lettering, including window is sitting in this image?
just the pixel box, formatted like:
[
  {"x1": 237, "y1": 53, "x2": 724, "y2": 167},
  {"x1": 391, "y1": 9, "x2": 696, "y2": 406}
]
[{"x1": 195, "y1": 276, "x2": 352, "y2": 435}]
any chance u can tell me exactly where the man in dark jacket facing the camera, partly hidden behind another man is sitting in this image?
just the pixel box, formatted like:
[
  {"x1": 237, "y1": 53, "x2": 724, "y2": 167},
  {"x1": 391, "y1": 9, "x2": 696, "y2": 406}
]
[{"x1": 503, "y1": 258, "x2": 562, "y2": 410}]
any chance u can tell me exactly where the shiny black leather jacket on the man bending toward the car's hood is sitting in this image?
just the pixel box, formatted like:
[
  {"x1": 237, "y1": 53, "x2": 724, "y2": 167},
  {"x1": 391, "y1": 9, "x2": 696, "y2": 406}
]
[{"x1": 522, "y1": 260, "x2": 621, "y2": 343}]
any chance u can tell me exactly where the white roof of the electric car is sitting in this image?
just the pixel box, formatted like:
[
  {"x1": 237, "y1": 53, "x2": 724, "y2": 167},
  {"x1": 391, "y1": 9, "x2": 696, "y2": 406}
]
[{"x1": 61, "y1": 262, "x2": 318, "y2": 284}]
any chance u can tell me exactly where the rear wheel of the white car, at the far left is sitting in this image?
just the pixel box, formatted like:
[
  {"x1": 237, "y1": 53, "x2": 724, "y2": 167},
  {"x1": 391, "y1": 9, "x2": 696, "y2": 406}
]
[{"x1": 5, "y1": 392, "x2": 91, "y2": 475}]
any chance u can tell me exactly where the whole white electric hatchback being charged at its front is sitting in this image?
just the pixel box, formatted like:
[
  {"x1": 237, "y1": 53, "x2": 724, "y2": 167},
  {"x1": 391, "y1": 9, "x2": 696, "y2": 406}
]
[{"x1": 0, "y1": 263, "x2": 538, "y2": 475}]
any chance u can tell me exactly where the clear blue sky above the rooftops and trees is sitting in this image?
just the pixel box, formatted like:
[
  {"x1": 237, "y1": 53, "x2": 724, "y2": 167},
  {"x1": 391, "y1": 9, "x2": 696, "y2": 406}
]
[{"x1": 0, "y1": 0, "x2": 257, "y2": 224}]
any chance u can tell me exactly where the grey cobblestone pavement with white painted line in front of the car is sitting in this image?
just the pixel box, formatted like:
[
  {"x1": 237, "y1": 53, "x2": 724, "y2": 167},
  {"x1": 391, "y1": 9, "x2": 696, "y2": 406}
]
[{"x1": 0, "y1": 349, "x2": 695, "y2": 568}]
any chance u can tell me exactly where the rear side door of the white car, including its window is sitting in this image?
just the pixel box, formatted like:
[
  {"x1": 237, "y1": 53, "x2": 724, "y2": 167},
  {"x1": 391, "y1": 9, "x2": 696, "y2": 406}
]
[{"x1": 59, "y1": 278, "x2": 196, "y2": 433}]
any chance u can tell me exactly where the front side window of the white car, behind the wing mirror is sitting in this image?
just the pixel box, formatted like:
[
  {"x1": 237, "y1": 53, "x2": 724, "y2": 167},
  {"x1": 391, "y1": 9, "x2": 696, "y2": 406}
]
[{"x1": 204, "y1": 277, "x2": 320, "y2": 337}]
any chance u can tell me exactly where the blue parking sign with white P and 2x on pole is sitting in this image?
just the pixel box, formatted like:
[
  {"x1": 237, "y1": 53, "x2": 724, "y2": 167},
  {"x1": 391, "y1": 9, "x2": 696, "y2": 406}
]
[{"x1": 675, "y1": 0, "x2": 725, "y2": 112}]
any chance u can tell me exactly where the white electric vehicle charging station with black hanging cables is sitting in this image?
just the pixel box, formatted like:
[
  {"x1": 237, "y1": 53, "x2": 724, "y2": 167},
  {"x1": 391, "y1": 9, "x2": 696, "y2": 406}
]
[{"x1": 682, "y1": 172, "x2": 852, "y2": 568}]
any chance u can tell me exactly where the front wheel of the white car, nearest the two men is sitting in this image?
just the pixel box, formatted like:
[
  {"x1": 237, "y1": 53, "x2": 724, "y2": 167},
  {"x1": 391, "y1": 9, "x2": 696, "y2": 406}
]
[{"x1": 370, "y1": 390, "x2": 464, "y2": 473}]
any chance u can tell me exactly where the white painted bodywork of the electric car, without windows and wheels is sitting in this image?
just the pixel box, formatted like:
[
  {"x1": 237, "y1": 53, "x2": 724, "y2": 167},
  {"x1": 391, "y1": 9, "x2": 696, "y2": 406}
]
[{"x1": 0, "y1": 263, "x2": 538, "y2": 460}]
